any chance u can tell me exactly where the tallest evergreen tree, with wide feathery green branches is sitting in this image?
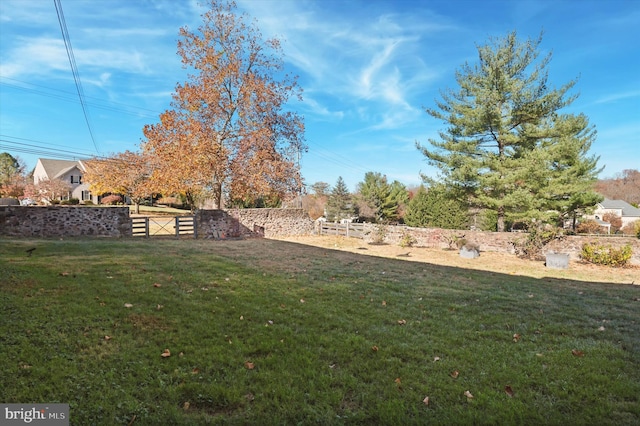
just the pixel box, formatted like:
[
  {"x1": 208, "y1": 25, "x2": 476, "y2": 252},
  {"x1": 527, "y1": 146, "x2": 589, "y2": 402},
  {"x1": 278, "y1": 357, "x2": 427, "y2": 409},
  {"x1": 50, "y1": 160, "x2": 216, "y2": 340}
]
[{"x1": 417, "y1": 31, "x2": 600, "y2": 231}]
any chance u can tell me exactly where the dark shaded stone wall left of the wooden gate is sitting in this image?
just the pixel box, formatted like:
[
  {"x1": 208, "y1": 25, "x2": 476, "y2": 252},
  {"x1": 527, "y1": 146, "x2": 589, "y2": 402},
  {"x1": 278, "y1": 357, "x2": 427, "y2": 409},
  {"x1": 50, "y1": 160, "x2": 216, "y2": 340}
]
[{"x1": 0, "y1": 206, "x2": 131, "y2": 237}]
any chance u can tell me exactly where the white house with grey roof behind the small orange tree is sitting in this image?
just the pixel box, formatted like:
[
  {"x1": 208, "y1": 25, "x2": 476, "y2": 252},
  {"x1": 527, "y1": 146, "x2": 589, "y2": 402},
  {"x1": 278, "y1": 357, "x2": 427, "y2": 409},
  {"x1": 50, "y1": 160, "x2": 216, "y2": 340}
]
[{"x1": 33, "y1": 158, "x2": 98, "y2": 203}]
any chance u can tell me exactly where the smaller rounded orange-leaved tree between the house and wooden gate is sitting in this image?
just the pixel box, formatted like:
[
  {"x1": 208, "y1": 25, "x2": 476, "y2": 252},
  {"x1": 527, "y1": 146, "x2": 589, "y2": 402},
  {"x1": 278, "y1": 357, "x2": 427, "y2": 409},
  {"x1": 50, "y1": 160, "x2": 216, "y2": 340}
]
[{"x1": 84, "y1": 151, "x2": 152, "y2": 213}]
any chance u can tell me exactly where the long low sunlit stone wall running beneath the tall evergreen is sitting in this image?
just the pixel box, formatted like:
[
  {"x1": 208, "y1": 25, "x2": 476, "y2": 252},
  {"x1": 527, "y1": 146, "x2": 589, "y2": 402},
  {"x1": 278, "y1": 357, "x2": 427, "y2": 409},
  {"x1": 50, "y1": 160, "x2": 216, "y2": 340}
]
[{"x1": 364, "y1": 224, "x2": 640, "y2": 265}]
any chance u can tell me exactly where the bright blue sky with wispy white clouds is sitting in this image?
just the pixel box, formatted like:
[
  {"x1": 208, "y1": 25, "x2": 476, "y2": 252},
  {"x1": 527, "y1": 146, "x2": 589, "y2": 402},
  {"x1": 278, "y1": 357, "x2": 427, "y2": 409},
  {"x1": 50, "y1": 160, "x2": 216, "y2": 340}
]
[{"x1": 0, "y1": 0, "x2": 640, "y2": 190}]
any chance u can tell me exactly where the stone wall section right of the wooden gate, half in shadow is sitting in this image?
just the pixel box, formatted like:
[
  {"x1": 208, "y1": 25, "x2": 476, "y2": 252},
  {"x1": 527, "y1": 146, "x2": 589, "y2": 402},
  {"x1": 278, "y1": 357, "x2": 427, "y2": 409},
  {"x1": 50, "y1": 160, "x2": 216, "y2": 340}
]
[{"x1": 196, "y1": 209, "x2": 314, "y2": 239}]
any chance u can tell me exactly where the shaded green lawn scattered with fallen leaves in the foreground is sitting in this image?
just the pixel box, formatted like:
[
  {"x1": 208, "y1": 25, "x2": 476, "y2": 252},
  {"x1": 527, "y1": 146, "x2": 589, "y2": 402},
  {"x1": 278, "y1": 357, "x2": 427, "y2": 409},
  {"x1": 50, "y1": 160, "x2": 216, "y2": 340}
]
[{"x1": 0, "y1": 239, "x2": 640, "y2": 425}]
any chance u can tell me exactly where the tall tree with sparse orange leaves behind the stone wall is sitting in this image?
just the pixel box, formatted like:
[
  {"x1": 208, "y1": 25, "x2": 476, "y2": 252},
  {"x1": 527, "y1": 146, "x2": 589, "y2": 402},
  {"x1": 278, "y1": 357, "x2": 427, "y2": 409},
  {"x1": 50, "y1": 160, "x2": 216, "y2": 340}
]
[{"x1": 142, "y1": 0, "x2": 305, "y2": 208}]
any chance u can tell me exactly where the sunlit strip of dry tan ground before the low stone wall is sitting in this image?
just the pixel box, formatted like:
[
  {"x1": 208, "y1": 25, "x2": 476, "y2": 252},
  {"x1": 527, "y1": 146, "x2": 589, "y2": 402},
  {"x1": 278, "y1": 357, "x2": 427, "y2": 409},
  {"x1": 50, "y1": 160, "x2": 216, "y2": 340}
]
[{"x1": 278, "y1": 235, "x2": 640, "y2": 285}]
